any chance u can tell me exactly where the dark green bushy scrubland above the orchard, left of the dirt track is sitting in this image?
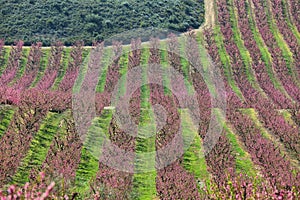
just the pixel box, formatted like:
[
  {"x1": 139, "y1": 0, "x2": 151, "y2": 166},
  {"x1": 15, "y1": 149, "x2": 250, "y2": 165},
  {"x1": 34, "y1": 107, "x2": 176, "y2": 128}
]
[{"x1": 0, "y1": 0, "x2": 204, "y2": 46}]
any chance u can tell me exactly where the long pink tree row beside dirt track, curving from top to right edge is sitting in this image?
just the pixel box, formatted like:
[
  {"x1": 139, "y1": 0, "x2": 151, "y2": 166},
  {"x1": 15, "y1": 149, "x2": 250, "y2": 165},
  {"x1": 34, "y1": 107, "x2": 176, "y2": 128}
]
[{"x1": 217, "y1": 0, "x2": 300, "y2": 159}]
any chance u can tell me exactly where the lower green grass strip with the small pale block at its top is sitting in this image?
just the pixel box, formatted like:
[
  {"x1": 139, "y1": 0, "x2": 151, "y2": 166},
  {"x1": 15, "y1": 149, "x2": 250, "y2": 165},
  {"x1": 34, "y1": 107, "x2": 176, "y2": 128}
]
[{"x1": 75, "y1": 110, "x2": 112, "y2": 194}]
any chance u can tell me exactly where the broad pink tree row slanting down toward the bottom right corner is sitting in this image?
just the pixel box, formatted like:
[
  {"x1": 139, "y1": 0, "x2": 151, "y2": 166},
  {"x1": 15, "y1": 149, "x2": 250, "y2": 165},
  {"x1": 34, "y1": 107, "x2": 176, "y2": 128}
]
[{"x1": 229, "y1": 108, "x2": 300, "y2": 191}]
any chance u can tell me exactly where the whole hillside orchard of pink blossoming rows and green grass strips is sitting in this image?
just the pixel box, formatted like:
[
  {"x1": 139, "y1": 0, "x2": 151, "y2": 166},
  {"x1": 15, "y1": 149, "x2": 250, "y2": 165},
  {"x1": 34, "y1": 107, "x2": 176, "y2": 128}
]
[{"x1": 0, "y1": 0, "x2": 300, "y2": 199}]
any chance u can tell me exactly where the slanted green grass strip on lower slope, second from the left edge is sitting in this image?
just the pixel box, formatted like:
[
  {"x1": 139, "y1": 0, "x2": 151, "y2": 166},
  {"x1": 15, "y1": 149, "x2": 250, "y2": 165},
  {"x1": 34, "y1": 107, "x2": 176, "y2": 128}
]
[{"x1": 12, "y1": 112, "x2": 64, "y2": 185}]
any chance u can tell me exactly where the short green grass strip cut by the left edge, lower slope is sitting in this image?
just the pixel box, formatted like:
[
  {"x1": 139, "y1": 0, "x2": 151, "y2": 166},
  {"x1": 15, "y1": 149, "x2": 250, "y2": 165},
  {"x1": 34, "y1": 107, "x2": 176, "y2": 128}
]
[{"x1": 0, "y1": 106, "x2": 15, "y2": 138}]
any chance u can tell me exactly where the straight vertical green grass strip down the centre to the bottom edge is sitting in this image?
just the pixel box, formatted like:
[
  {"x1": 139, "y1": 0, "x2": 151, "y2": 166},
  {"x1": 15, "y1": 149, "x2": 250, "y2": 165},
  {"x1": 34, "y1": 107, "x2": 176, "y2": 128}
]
[{"x1": 133, "y1": 62, "x2": 157, "y2": 200}]
